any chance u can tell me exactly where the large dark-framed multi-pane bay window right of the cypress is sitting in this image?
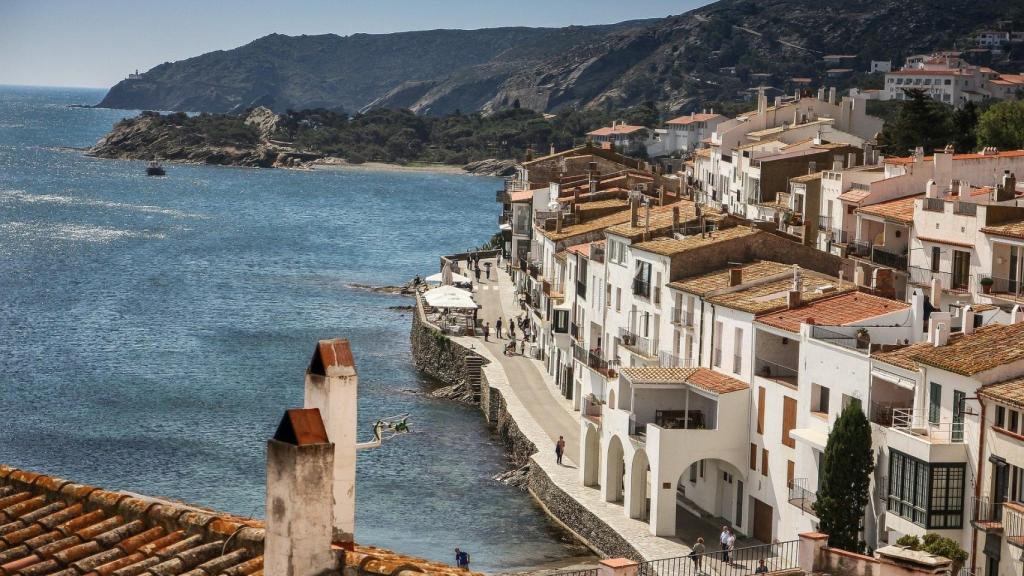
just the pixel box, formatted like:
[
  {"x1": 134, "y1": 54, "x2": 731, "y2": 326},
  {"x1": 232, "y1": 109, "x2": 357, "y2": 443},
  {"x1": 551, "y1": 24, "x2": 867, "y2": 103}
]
[{"x1": 888, "y1": 450, "x2": 966, "y2": 529}]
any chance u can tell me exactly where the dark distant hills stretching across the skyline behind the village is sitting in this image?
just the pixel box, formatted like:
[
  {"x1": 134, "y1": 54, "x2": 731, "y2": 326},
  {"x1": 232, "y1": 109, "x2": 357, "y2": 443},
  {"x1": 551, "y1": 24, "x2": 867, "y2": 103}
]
[{"x1": 98, "y1": 0, "x2": 1024, "y2": 114}]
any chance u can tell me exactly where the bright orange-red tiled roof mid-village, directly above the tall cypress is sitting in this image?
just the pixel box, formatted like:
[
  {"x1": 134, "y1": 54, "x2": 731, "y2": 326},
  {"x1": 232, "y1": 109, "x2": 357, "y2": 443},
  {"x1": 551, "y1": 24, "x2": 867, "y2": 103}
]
[{"x1": 758, "y1": 292, "x2": 910, "y2": 332}]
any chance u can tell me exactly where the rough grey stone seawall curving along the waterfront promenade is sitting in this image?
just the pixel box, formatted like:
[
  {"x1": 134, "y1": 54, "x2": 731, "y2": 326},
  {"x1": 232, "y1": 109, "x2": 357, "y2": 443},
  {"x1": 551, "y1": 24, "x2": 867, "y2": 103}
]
[{"x1": 411, "y1": 302, "x2": 643, "y2": 561}]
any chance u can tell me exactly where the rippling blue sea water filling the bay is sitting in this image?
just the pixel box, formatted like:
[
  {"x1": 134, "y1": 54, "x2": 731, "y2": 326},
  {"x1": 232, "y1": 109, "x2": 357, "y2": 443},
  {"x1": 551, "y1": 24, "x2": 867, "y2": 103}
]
[{"x1": 0, "y1": 87, "x2": 568, "y2": 571}]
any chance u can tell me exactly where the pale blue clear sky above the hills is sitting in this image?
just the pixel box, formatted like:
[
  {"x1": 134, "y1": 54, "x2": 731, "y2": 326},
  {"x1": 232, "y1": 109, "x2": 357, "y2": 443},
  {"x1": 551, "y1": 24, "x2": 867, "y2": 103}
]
[{"x1": 0, "y1": 0, "x2": 709, "y2": 88}]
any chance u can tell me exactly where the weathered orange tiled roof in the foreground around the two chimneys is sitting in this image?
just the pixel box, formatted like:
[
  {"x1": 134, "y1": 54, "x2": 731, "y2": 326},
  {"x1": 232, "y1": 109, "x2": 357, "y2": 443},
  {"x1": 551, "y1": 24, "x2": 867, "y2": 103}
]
[{"x1": 0, "y1": 465, "x2": 475, "y2": 576}]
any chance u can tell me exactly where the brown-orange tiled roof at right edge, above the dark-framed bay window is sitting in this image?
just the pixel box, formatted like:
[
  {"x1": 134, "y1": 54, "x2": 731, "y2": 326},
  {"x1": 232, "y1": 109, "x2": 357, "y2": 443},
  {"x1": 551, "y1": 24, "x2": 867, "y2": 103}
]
[{"x1": 873, "y1": 322, "x2": 1024, "y2": 376}]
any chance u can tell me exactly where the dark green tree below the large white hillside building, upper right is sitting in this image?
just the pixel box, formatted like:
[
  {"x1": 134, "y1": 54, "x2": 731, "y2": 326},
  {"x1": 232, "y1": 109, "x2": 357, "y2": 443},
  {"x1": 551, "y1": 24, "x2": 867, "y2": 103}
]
[{"x1": 880, "y1": 89, "x2": 955, "y2": 156}]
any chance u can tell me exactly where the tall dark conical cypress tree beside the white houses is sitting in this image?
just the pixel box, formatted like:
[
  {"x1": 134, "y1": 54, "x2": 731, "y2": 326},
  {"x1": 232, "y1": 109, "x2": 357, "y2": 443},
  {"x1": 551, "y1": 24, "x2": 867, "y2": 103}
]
[{"x1": 814, "y1": 402, "x2": 874, "y2": 552}]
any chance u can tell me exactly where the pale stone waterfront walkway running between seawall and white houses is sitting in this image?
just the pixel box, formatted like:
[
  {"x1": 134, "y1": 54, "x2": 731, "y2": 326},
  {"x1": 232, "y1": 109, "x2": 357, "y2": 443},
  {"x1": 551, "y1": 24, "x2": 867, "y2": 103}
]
[{"x1": 455, "y1": 258, "x2": 696, "y2": 560}]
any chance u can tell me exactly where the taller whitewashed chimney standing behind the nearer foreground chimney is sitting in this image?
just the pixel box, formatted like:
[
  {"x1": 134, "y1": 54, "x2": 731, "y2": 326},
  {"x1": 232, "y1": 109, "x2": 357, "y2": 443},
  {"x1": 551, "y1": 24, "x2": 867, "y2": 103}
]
[{"x1": 303, "y1": 338, "x2": 359, "y2": 541}]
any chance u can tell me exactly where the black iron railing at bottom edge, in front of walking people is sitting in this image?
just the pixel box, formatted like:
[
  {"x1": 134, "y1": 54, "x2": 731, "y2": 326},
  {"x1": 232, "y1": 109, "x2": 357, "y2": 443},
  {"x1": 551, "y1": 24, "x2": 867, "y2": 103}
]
[{"x1": 637, "y1": 540, "x2": 800, "y2": 576}]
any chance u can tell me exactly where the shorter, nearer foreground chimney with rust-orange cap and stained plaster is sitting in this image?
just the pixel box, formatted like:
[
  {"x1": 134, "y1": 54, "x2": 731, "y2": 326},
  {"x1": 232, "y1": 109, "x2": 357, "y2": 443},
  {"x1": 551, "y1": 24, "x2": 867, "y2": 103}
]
[{"x1": 263, "y1": 408, "x2": 337, "y2": 576}]
